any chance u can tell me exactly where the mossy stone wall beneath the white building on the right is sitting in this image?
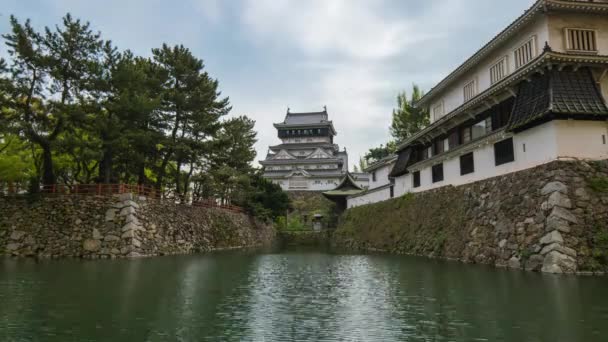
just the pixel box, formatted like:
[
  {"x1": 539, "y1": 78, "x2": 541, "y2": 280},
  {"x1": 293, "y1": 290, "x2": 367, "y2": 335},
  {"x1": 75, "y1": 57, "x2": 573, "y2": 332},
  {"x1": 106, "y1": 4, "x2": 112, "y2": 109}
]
[{"x1": 332, "y1": 161, "x2": 608, "y2": 274}]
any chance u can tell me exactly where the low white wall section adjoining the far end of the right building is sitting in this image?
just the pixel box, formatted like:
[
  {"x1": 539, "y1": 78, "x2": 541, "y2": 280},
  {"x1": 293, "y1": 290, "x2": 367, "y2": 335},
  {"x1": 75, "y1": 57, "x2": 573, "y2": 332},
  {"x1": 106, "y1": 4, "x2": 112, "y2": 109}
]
[{"x1": 347, "y1": 155, "x2": 397, "y2": 208}]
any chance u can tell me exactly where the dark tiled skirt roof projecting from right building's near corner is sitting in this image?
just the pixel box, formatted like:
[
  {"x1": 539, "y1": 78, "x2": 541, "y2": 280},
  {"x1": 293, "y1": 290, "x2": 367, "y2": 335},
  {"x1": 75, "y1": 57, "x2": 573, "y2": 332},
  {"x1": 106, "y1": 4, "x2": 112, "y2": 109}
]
[{"x1": 508, "y1": 68, "x2": 608, "y2": 130}]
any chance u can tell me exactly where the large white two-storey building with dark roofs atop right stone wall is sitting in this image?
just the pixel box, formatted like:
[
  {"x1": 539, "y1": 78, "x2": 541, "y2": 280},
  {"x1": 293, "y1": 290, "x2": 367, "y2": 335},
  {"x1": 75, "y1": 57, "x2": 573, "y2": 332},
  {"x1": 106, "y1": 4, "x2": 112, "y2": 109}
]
[{"x1": 382, "y1": 0, "x2": 608, "y2": 196}]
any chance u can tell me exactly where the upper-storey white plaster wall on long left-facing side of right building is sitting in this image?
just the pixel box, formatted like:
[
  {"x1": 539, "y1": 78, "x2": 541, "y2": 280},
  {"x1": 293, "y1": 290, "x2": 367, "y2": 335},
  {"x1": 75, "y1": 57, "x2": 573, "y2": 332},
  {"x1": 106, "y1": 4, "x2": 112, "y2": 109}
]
[{"x1": 429, "y1": 15, "x2": 549, "y2": 122}]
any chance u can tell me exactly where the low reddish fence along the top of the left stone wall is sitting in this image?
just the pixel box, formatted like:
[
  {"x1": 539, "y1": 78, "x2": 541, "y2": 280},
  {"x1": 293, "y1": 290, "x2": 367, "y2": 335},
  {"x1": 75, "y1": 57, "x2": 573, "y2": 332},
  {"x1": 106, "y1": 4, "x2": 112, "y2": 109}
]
[{"x1": 0, "y1": 184, "x2": 245, "y2": 213}]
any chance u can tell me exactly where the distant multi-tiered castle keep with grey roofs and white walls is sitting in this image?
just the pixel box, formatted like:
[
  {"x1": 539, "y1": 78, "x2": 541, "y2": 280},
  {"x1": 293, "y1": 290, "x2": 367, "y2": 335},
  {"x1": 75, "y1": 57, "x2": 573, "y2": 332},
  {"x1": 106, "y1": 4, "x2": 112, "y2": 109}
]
[{"x1": 260, "y1": 109, "x2": 367, "y2": 191}]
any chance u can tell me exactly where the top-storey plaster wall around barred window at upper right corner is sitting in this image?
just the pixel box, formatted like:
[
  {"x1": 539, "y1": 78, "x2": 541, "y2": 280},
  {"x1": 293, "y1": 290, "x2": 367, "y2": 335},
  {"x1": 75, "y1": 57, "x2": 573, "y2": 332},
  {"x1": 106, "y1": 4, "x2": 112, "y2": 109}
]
[{"x1": 549, "y1": 13, "x2": 608, "y2": 55}]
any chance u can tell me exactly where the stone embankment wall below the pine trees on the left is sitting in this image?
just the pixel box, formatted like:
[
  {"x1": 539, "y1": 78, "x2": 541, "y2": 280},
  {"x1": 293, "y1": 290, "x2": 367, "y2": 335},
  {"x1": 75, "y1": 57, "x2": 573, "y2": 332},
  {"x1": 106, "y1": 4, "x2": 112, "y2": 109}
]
[{"x1": 0, "y1": 194, "x2": 274, "y2": 258}]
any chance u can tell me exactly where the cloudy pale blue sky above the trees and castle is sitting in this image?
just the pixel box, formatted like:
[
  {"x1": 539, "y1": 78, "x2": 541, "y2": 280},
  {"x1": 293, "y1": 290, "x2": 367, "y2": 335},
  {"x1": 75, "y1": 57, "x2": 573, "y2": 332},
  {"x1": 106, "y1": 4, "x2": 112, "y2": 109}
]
[{"x1": 0, "y1": 0, "x2": 533, "y2": 166}]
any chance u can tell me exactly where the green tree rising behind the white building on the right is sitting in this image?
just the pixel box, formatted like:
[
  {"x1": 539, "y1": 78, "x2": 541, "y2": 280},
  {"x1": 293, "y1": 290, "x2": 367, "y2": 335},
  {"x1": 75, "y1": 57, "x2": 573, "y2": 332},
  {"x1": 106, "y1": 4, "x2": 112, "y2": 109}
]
[{"x1": 390, "y1": 85, "x2": 430, "y2": 142}]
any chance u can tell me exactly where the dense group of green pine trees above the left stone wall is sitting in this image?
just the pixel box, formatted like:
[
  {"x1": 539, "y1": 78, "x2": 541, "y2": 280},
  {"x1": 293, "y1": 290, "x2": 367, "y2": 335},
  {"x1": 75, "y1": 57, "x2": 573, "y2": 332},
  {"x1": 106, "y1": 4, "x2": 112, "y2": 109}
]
[{"x1": 0, "y1": 14, "x2": 288, "y2": 216}]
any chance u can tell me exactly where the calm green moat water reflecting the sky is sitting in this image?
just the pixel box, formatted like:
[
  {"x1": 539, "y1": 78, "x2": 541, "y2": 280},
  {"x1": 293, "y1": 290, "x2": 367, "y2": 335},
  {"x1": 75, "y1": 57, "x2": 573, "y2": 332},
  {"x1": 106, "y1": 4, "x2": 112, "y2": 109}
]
[{"x1": 0, "y1": 248, "x2": 608, "y2": 341}]
